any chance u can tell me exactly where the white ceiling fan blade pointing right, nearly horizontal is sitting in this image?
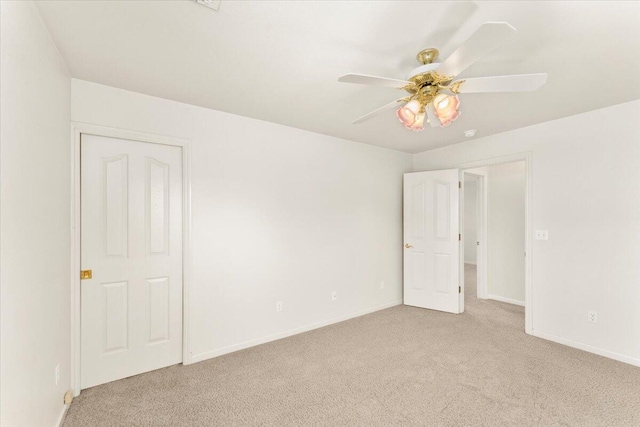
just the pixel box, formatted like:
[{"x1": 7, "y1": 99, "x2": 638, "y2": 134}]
[{"x1": 451, "y1": 73, "x2": 547, "y2": 93}]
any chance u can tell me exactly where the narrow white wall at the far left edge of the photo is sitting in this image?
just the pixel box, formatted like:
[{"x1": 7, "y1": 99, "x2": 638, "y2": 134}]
[{"x1": 0, "y1": 1, "x2": 70, "y2": 427}]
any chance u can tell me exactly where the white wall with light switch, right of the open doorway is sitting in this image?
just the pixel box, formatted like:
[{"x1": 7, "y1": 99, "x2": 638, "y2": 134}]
[{"x1": 414, "y1": 101, "x2": 640, "y2": 365}]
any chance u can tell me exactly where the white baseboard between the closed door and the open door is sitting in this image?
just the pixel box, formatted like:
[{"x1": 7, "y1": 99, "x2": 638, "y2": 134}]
[{"x1": 191, "y1": 300, "x2": 402, "y2": 363}]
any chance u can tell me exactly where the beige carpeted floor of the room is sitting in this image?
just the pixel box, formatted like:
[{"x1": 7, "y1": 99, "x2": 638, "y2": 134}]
[{"x1": 64, "y1": 266, "x2": 640, "y2": 427}]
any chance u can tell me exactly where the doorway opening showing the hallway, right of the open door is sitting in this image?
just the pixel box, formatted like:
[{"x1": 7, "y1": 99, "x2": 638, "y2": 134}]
[{"x1": 461, "y1": 161, "x2": 527, "y2": 306}]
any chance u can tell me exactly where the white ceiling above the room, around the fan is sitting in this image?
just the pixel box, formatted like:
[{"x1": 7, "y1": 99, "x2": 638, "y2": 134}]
[{"x1": 37, "y1": 0, "x2": 640, "y2": 153}]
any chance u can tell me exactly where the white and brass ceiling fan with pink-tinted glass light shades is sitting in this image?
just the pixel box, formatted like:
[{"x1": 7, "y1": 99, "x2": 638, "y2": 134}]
[{"x1": 338, "y1": 22, "x2": 547, "y2": 131}]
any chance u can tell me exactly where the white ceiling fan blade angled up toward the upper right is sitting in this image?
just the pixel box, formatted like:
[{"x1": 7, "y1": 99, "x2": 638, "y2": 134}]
[{"x1": 437, "y1": 22, "x2": 516, "y2": 77}]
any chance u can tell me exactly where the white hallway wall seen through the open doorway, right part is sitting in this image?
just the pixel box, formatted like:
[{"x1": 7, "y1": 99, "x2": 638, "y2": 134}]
[{"x1": 487, "y1": 162, "x2": 527, "y2": 305}]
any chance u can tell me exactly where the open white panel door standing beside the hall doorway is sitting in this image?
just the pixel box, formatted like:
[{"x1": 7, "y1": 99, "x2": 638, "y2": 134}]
[{"x1": 404, "y1": 169, "x2": 461, "y2": 313}]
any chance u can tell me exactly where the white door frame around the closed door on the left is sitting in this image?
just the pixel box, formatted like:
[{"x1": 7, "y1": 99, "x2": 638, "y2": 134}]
[{"x1": 70, "y1": 122, "x2": 193, "y2": 396}]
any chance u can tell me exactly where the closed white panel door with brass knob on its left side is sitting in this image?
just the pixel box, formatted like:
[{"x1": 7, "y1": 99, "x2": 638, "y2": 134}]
[{"x1": 80, "y1": 135, "x2": 182, "y2": 389}]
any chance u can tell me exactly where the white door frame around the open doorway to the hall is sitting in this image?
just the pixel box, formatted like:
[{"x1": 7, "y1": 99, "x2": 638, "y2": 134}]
[{"x1": 455, "y1": 151, "x2": 533, "y2": 335}]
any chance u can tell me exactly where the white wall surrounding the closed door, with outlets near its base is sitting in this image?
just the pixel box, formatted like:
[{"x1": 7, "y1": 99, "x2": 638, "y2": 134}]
[{"x1": 71, "y1": 80, "x2": 412, "y2": 361}]
